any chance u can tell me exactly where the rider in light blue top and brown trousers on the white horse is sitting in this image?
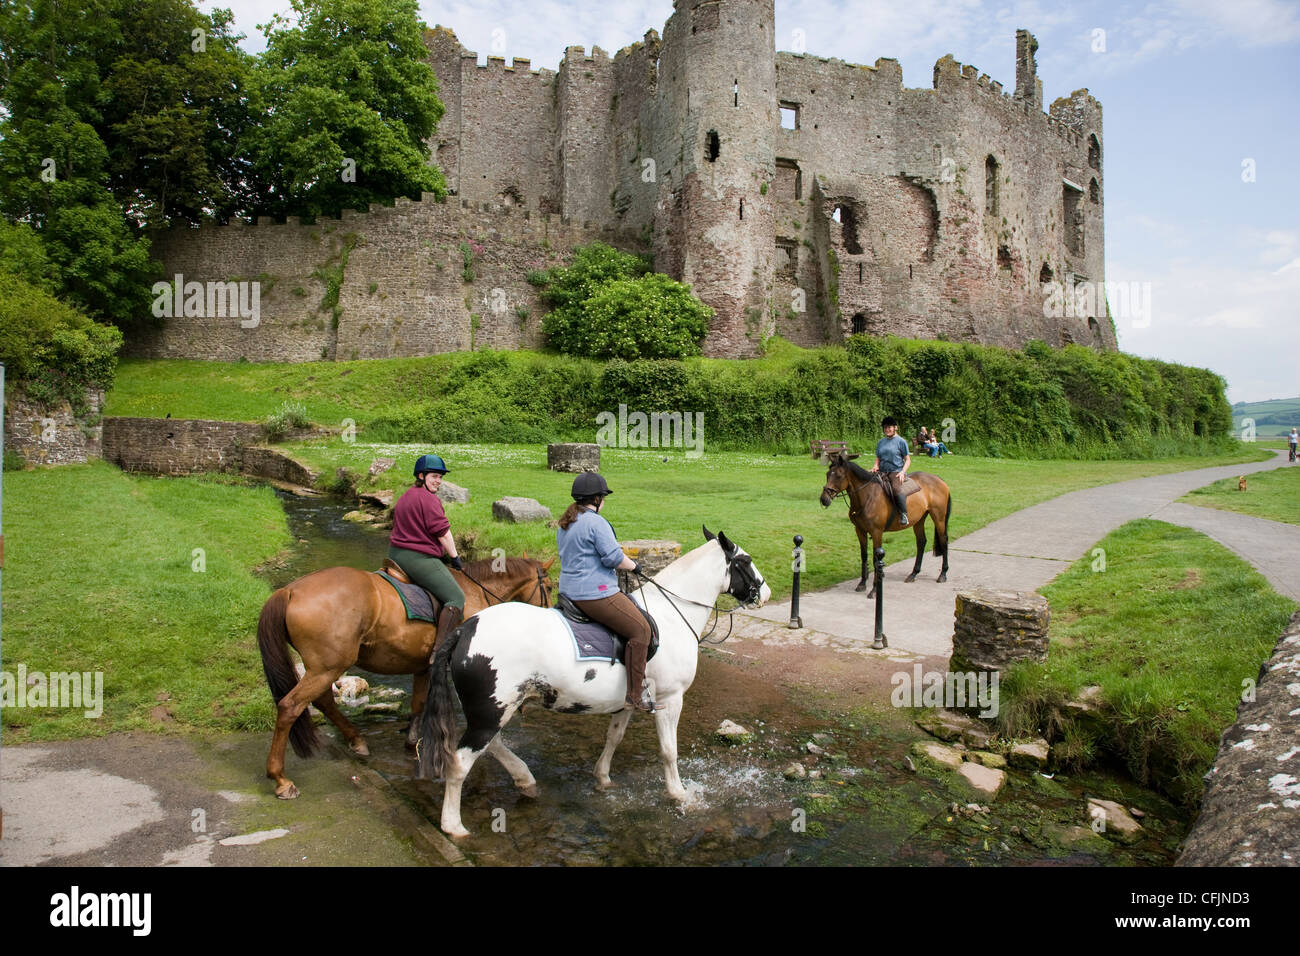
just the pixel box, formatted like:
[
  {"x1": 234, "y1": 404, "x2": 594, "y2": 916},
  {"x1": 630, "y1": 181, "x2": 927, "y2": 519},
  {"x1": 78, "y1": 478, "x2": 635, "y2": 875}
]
[{"x1": 555, "y1": 471, "x2": 663, "y2": 713}]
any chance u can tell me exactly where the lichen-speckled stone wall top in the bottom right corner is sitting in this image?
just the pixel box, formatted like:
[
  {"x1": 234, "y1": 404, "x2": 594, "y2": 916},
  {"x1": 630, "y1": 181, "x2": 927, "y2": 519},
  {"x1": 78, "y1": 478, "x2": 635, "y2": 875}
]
[{"x1": 1175, "y1": 611, "x2": 1300, "y2": 866}]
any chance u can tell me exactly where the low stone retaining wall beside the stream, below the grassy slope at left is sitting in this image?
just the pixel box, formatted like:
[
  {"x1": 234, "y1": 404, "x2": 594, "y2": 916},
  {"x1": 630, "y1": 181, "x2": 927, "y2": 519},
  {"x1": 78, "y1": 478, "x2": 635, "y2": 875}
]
[{"x1": 104, "y1": 418, "x2": 317, "y2": 486}]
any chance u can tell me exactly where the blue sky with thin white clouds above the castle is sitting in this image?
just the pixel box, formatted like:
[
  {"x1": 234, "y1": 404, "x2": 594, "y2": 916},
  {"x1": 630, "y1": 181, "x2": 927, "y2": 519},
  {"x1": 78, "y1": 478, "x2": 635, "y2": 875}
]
[{"x1": 200, "y1": 0, "x2": 1300, "y2": 402}]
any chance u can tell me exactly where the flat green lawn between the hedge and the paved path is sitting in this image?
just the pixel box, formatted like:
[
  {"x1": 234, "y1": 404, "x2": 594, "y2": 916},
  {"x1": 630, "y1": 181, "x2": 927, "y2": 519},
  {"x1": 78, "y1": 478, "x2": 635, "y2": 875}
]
[{"x1": 285, "y1": 438, "x2": 1266, "y2": 597}]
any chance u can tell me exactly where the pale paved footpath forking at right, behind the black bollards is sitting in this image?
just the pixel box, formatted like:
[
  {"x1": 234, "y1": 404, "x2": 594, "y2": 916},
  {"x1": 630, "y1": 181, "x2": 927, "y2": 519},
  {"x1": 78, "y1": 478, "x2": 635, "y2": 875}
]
[{"x1": 736, "y1": 451, "x2": 1300, "y2": 662}]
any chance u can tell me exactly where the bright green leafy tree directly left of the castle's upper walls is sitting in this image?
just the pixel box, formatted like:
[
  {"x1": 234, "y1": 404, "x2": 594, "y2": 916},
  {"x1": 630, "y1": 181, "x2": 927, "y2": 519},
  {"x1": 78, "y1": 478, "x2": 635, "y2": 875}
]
[{"x1": 248, "y1": 0, "x2": 446, "y2": 216}]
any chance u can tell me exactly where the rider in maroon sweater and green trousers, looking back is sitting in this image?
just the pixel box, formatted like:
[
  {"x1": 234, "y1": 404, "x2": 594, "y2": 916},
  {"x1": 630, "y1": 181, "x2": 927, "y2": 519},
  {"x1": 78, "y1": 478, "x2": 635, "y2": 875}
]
[{"x1": 389, "y1": 455, "x2": 465, "y2": 644}]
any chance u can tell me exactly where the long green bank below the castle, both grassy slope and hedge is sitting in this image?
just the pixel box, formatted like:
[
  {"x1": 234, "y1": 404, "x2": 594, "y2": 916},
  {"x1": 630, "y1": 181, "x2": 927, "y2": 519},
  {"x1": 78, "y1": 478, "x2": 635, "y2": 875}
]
[{"x1": 105, "y1": 336, "x2": 1231, "y2": 459}]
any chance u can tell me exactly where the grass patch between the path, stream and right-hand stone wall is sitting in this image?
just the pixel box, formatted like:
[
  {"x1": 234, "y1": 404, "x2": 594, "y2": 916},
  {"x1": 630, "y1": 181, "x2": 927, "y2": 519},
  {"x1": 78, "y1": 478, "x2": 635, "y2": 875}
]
[{"x1": 998, "y1": 520, "x2": 1295, "y2": 806}]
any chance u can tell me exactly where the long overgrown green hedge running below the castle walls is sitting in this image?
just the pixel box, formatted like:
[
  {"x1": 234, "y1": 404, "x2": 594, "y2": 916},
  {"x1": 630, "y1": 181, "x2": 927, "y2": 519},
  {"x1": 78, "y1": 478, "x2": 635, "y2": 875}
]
[{"x1": 365, "y1": 336, "x2": 1232, "y2": 458}]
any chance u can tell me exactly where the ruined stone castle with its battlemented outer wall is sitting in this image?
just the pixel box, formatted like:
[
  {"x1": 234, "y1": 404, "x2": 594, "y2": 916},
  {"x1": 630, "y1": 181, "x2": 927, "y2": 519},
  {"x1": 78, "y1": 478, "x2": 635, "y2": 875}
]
[{"x1": 131, "y1": 0, "x2": 1115, "y2": 360}]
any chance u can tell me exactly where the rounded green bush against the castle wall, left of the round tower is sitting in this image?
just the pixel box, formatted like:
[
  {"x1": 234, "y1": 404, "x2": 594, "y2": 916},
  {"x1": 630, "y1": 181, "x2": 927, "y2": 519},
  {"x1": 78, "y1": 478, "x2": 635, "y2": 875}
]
[{"x1": 529, "y1": 242, "x2": 714, "y2": 359}]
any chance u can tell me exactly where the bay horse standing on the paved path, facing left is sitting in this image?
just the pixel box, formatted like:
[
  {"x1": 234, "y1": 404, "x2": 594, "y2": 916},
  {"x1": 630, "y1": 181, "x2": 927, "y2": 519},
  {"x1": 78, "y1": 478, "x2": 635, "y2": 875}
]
[{"x1": 820, "y1": 451, "x2": 953, "y2": 597}]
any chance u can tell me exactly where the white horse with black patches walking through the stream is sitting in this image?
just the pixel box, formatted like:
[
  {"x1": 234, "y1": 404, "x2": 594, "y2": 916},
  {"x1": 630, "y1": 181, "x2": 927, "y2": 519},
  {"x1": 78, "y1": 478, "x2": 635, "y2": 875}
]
[{"x1": 416, "y1": 528, "x2": 772, "y2": 836}]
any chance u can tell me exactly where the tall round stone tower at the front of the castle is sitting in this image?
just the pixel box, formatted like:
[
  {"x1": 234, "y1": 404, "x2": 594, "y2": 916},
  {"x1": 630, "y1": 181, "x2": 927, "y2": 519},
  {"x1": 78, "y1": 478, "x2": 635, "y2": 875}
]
[{"x1": 655, "y1": 0, "x2": 776, "y2": 356}]
